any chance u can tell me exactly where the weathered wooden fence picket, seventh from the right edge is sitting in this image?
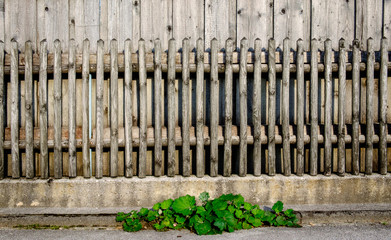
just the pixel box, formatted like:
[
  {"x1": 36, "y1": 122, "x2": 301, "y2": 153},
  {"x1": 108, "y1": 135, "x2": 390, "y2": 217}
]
[{"x1": 296, "y1": 39, "x2": 305, "y2": 176}]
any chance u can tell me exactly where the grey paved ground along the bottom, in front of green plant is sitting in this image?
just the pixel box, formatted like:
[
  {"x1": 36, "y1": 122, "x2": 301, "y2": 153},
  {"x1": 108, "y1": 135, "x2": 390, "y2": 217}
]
[{"x1": 0, "y1": 223, "x2": 391, "y2": 240}]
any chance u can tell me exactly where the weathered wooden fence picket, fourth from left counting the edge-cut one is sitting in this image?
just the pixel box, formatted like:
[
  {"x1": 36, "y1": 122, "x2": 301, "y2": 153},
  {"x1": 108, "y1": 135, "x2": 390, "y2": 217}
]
[{"x1": 39, "y1": 40, "x2": 49, "y2": 179}]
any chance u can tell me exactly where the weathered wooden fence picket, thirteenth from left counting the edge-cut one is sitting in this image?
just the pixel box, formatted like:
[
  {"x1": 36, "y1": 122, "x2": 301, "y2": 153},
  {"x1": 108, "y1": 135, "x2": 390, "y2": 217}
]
[{"x1": 167, "y1": 39, "x2": 176, "y2": 177}]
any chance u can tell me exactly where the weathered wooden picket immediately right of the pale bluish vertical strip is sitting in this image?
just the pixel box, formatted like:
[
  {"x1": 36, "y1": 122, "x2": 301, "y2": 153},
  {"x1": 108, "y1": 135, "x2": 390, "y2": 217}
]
[{"x1": 95, "y1": 39, "x2": 104, "y2": 178}]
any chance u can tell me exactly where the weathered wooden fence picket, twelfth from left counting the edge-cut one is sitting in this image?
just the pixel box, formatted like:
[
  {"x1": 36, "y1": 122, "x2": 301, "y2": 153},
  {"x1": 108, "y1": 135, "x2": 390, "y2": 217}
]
[{"x1": 154, "y1": 39, "x2": 163, "y2": 177}]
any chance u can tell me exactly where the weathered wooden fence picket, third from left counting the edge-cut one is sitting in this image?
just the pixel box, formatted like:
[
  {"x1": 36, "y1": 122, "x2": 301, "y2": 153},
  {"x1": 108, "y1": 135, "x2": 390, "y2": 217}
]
[{"x1": 24, "y1": 41, "x2": 35, "y2": 178}]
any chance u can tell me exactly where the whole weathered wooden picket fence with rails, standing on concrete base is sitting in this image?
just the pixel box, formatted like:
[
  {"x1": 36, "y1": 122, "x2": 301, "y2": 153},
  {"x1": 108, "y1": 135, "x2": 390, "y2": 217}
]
[{"x1": 0, "y1": 38, "x2": 391, "y2": 179}]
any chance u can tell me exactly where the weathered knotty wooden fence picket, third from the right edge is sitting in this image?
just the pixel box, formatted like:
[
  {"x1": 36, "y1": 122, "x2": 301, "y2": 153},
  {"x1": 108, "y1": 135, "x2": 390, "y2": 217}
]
[{"x1": 352, "y1": 40, "x2": 361, "y2": 175}]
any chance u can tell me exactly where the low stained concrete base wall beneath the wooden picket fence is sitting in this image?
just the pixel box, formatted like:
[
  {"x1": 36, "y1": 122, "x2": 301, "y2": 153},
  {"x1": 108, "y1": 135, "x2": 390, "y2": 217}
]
[{"x1": 0, "y1": 174, "x2": 391, "y2": 208}]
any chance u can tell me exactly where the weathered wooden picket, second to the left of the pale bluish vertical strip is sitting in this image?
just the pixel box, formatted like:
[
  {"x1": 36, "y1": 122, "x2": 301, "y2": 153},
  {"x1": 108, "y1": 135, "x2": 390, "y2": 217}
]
[{"x1": 68, "y1": 39, "x2": 77, "y2": 177}]
